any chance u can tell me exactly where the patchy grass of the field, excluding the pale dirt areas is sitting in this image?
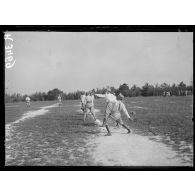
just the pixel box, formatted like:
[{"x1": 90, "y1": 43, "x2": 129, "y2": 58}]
[{"x1": 5, "y1": 96, "x2": 193, "y2": 166}]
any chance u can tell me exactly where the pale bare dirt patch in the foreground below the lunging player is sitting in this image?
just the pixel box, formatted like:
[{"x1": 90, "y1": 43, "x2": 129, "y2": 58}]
[{"x1": 79, "y1": 106, "x2": 192, "y2": 166}]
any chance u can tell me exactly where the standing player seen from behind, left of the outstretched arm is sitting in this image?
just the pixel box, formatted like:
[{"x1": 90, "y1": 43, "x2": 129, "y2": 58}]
[{"x1": 84, "y1": 92, "x2": 96, "y2": 122}]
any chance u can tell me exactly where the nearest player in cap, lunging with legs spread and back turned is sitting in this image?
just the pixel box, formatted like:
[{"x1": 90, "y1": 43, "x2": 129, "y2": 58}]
[{"x1": 103, "y1": 94, "x2": 133, "y2": 136}]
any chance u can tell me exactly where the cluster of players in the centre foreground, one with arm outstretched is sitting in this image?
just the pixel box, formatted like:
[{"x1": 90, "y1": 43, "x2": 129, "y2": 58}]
[{"x1": 80, "y1": 88, "x2": 135, "y2": 136}]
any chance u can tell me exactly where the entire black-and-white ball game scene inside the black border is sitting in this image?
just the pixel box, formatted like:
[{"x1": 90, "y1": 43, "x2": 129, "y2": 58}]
[{"x1": 4, "y1": 26, "x2": 194, "y2": 169}]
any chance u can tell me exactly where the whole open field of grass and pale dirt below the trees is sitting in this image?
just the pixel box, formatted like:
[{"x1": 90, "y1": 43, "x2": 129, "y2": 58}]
[{"x1": 5, "y1": 96, "x2": 193, "y2": 166}]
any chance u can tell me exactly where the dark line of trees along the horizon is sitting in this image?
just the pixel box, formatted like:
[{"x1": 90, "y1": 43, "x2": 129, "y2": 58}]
[{"x1": 5, "y1": 81, "x2": 193, "y2": 103}]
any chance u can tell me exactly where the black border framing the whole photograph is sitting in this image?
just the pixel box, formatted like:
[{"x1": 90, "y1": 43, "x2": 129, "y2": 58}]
[{"x1": 0, "y1": 25, "x2": 195, "y2": 171}]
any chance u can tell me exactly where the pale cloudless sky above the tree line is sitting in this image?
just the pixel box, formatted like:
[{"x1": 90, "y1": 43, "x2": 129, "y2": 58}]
[{"x1": 5, "y1": 32, "x2": 193, "y2": 94}]
